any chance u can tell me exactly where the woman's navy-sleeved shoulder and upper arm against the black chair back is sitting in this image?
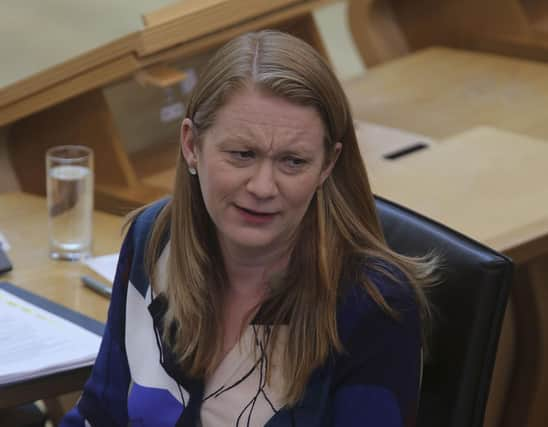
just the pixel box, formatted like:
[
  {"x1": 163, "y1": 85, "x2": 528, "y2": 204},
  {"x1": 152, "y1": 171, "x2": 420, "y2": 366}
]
[{"x1": 332, "y1": 262, "x2": 421, "y2": 425}]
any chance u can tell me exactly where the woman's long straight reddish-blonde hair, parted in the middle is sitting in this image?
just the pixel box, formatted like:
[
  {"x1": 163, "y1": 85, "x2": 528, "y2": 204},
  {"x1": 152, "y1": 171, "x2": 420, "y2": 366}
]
[{"x1": 136, "y1": 31, "x2": 433, "y2": 404}]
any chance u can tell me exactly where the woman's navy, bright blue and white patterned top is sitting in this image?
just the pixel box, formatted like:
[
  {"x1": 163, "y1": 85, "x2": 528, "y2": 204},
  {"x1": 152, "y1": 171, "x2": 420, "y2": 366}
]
[{"x1": 61, "y1": 201, "x2": 421, "y2": 427}]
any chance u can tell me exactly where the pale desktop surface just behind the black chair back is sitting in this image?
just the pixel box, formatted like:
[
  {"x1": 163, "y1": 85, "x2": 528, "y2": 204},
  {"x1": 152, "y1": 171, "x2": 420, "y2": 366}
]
[{"x1": 358, "y1": 127, "x2": 548, "y2": 261}]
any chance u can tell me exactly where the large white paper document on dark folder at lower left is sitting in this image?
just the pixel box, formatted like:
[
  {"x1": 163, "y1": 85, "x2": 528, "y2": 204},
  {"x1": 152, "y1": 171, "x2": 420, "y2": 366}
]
[{"x1": 0, "y1": 289, "x2": 101, "y2": 384}]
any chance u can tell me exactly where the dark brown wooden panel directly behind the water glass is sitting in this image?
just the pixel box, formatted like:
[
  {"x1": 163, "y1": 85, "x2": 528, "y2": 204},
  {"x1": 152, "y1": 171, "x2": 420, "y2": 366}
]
[{"x1": 8, "y1": 91, "x2": 138, "y2": 194}]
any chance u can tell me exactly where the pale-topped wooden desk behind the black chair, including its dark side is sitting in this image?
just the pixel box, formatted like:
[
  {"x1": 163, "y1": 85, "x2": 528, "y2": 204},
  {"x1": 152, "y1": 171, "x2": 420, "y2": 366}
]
[{"x1": 358, "y1": 127, "x2": 548, "y2": 427}]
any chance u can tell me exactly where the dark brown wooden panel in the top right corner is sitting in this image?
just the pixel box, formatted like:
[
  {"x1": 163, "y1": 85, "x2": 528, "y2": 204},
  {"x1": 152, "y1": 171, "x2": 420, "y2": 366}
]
[{"x1": 348, "y1": 0, "x2": 548, "y2": 66}]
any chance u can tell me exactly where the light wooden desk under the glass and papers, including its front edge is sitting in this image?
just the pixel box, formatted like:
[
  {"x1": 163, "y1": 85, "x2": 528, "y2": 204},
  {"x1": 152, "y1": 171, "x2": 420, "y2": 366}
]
[{"x1": 0, "y1": 193, "x2": 123, "y2": 408}]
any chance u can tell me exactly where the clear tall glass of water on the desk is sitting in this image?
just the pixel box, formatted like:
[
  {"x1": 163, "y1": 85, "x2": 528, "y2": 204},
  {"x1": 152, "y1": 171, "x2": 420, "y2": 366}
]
[{"x1": 46, "y1": 145, "x2": 93, "y2": 260}]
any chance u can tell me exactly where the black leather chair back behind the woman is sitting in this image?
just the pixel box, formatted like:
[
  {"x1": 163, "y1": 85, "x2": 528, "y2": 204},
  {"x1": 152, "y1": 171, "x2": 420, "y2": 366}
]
[{"x1": 376, "y1": 197, "x2": 513, "y2": 427}]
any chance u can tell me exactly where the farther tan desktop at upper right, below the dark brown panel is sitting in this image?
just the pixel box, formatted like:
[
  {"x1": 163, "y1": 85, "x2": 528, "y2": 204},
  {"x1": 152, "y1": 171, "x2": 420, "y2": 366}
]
[{"x1": 344, "y1": 48, "x2": 548, "y2": 141}]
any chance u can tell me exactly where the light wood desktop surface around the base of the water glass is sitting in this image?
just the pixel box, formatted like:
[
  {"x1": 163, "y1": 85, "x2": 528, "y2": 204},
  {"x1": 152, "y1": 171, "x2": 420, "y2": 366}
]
[{"x1": 0, "y1": 193, "x2": 123, "y2": 322}]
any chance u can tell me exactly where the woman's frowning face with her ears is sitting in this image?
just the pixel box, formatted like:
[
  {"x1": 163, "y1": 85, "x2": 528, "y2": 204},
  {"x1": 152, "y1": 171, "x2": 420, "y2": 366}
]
[{"x1": 182, "y1": 89, "x2": 341, "y2": 251}]
